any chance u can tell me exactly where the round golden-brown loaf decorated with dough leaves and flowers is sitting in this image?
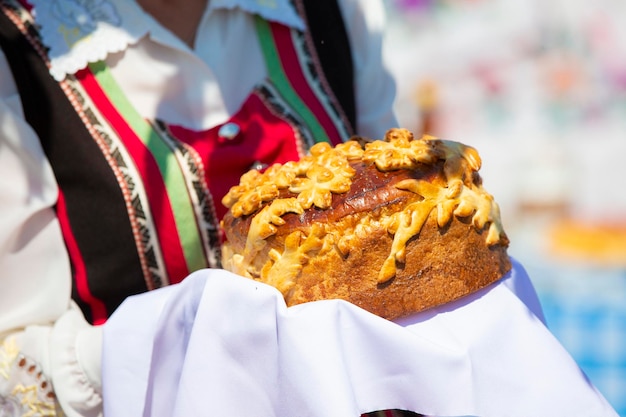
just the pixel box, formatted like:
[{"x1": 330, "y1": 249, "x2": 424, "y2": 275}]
[{"x1": 222, "y1": 130, "x2": 511, "y2": 319}]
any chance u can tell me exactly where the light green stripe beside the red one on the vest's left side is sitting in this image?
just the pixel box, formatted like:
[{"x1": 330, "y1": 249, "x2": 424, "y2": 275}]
[{"x1": 89, "y1": 61, "x2": 207, "y2": 272}]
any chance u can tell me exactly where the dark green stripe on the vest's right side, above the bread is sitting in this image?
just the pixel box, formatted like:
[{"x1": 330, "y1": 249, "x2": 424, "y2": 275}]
[{"x1": 256, "y1": 16, "x2": 330, "y2": 142}]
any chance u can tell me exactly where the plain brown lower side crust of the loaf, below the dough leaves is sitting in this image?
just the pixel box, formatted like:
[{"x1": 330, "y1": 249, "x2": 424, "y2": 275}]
[{"x1": 288, "y1": 211, "x2": 510, "y2": 320}]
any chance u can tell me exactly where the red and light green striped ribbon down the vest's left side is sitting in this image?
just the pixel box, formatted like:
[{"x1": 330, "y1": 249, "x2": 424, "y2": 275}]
[{"x1": 80, "y1": 62, "x2": 208, "y2": 282}]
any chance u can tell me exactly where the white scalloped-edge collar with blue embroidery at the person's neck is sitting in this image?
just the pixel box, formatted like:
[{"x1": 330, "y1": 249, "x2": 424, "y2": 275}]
[{"x1": 30, "y1": 0, "x2": 304, "y2": 81}]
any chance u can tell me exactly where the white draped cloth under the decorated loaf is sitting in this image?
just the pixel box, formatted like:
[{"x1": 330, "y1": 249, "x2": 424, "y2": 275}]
[{"x1": 103, "y1": 256, "x2": 617, "y2": 417}]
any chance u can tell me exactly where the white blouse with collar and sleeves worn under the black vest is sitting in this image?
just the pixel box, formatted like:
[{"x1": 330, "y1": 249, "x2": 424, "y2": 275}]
[{"x1": 0, "y1": 0, "x2": 397, "y2": 416}]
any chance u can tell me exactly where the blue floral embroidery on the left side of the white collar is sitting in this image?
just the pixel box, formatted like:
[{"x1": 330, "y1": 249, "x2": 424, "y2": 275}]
[{"x1": 51, "y1": 0, "x2": 121, "y2": 47}]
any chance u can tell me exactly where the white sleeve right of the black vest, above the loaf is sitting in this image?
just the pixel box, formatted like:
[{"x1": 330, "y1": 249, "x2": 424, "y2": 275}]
[{"x1": 339, "y1": 0, "x2": 398, "y2": 139}]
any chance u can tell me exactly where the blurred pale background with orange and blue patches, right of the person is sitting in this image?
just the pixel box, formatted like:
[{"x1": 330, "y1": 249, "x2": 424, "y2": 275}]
[{"x1": 385, "y1": 0, "x2": 626, "y2": 417}]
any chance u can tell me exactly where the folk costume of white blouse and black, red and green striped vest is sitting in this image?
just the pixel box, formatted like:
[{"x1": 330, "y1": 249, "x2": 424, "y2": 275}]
[{"x1": 0, "y1": 0, "x2": 396, "y2": 415}]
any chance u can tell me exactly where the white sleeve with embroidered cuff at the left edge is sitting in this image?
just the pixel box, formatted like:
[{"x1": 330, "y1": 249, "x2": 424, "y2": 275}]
[{"x1": 0, "y1": 51, "x2": 101, "y2": 416}]
